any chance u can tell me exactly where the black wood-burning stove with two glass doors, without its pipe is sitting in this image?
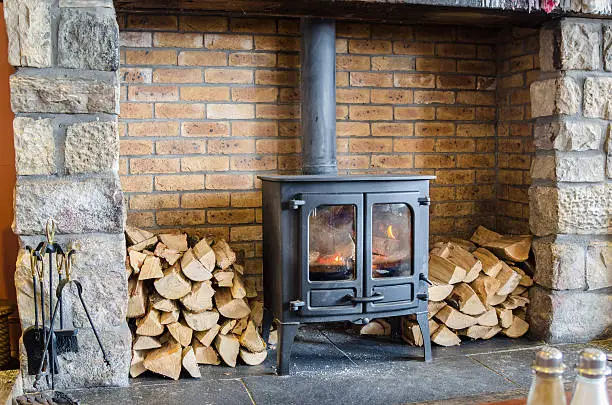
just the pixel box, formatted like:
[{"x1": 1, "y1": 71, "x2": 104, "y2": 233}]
[{"x1": 260, "y1": 175, "x2": 433, "y2": 375}]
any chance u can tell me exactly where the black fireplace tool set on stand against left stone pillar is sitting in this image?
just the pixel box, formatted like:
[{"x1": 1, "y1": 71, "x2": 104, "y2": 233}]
[{"x1": 23, "y1": 219, "x2": 110, "y2": 403}]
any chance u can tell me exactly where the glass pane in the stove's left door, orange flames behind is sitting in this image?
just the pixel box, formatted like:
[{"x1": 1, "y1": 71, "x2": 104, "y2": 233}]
[{"x1": 308, "y1": 204, "x2": 357, "y2": 281}]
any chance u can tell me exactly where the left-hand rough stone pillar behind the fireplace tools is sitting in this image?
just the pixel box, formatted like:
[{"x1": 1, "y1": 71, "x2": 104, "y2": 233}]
[{"x1": 4, "y1": 0, "x2": 131, "y2": 389}]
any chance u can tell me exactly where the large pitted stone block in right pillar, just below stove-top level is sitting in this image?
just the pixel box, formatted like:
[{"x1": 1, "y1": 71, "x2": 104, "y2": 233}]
[{"x1": 529, "y1": 184, "x2": 612, "y2": 236}]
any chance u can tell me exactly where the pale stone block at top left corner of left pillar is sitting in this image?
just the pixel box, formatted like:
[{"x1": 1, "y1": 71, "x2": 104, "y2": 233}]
[{"x1": 4, "y1": 0, "x2": 53, "y2": 68}]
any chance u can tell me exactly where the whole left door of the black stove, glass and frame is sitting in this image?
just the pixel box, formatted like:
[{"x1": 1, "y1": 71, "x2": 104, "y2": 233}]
[{"x1": 300, "y1": 194, "x2": 364, "y2": 316}]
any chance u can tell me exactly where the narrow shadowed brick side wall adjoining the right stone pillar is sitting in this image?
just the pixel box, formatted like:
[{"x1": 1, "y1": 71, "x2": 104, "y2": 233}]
[{"x1": 496, "y1": 28, "x2": 540, "y2": 234}]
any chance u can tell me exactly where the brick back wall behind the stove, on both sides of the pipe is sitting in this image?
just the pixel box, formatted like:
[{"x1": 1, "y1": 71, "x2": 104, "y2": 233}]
[{"x1": 119, "y1": 15, "x2": 506, "y2": 284}]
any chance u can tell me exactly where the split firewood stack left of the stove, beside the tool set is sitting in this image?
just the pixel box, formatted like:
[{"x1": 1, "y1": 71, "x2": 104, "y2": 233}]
[{"x1": 126, "y1": 227, "x2": 266, "y2": 380}]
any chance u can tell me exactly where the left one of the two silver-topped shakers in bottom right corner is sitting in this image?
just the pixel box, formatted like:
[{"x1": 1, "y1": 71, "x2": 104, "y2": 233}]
[{"x1": 527, "y1": 347, "x2": 567, "y2": 405}]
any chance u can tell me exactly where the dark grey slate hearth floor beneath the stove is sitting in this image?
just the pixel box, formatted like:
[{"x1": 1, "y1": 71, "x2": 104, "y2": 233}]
[{"x1": 64, "y1": 325, "x2": 612, "y2": 405}]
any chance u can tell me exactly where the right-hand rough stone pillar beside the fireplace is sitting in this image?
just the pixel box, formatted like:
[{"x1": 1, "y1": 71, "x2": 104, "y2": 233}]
[{"x1": 529, "y1": 19, "x2": 612, "y2": 342}]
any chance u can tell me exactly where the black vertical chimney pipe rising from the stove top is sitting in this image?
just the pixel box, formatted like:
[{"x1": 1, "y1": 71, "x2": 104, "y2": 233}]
[{"x1": 301, "y1": 17, "x2": 338, "y2": 174}]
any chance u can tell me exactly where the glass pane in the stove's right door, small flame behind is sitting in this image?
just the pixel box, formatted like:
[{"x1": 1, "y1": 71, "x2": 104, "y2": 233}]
[{"x1": 371, "y1": 203, "x2": 414, "y2": 279}]
